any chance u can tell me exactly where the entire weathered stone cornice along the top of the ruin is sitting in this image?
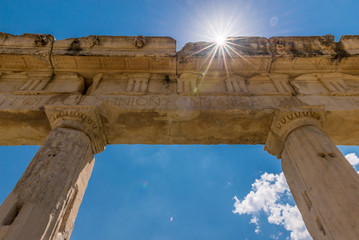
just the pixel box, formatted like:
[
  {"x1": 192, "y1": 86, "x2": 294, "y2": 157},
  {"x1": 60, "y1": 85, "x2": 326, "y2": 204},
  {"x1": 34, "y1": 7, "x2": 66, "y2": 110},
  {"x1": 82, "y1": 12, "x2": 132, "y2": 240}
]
[{"x1": 0, "y1": 33, "x2": 359, "y2": 74}]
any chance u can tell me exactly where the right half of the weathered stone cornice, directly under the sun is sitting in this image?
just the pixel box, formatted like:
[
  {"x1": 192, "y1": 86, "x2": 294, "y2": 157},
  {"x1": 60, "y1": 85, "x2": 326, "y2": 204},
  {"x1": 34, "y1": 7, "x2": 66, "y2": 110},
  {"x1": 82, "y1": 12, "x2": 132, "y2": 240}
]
[{"x1": 177, "y1": 35, "x2": 359, "y2": 76}]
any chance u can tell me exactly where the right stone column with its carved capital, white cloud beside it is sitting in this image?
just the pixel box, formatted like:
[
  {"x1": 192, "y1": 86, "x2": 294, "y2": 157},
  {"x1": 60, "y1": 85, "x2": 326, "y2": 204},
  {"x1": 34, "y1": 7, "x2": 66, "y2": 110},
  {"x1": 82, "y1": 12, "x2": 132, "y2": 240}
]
[{"x1": 265, "y1": 111, "x2": 359, "y2": 240}]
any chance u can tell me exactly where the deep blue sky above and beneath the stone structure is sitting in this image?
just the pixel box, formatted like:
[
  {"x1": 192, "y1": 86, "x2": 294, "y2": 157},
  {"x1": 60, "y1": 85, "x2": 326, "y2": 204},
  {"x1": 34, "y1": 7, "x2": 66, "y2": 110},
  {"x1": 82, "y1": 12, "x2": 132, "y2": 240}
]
[{"x1": 0, "y1": 0, "x2": 359, "y2": 240}]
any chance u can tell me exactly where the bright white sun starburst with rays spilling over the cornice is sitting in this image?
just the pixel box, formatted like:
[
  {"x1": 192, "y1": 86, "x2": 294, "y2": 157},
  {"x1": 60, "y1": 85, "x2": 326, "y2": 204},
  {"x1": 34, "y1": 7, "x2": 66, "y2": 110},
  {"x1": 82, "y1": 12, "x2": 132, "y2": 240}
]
[{"x1": 179, "y1": 0, "x2": 255, "y2": 95}]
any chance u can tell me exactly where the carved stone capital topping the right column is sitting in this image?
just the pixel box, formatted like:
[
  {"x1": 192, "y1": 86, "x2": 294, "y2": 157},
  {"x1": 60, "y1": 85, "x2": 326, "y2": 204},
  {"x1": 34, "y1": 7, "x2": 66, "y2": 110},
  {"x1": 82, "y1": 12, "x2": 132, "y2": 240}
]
[{"x1": 264, "y1": 107, "x2": 325, "y2": 159}]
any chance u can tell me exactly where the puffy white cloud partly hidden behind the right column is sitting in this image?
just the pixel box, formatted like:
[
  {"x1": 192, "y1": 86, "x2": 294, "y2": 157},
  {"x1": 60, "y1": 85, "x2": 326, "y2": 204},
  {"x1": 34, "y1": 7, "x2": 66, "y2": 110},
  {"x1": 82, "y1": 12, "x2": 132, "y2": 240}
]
[{"x1": 233, "y1": 153, "x2": 359, "y2": 240}]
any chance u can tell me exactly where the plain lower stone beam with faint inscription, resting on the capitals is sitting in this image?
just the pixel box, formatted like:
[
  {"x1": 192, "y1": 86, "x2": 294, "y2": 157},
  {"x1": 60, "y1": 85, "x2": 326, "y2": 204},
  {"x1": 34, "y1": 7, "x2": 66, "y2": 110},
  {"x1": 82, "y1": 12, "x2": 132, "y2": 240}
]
[{"x1": 0, "y1": 95, "x2": 359, "y2": 145}]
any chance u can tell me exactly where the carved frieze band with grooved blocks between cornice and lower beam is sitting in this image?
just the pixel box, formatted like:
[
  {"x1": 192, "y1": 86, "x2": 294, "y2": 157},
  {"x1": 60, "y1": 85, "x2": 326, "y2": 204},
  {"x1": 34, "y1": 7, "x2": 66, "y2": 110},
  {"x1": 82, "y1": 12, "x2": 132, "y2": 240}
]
[{"x1": 0, "y1": 71, "x2": 359, "y2": 96}]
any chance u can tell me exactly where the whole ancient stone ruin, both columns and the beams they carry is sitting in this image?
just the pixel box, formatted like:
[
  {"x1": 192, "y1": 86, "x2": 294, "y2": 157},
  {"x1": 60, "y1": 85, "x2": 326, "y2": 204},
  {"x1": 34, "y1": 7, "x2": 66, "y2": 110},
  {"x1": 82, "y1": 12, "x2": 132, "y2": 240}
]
[{"x1": 0, "y1": 33, "x2": 359, "y2": 240}]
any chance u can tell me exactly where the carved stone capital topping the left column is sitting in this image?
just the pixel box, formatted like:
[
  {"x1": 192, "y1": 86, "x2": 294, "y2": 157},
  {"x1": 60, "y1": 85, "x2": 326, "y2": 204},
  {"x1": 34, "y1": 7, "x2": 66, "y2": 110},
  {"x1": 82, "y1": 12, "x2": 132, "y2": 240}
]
[{"x1": 45, "y1": 105, "x2": 107, "y2": 154}]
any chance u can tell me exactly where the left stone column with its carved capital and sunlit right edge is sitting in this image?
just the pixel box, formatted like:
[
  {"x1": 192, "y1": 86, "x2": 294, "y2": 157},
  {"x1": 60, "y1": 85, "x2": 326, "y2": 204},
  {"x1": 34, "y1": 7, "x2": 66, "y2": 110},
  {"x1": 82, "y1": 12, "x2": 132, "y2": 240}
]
[{"x1": 0, "y1": 106, "x2": 106, "y2": 240}]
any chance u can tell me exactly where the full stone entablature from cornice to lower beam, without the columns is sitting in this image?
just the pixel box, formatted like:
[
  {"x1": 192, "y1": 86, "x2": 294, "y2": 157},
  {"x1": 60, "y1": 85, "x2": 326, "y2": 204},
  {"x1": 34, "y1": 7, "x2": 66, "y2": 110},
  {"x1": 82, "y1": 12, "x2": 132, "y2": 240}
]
[{"x1": 0, "y1": 33, "x2": 359, "y2": 145}]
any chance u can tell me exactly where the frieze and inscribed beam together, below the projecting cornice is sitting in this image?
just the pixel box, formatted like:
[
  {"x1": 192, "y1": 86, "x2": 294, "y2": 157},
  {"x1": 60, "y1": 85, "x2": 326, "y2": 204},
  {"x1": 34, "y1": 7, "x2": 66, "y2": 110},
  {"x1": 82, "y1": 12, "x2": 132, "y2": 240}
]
[{"x1": 0, "y1": 70, "x2": 359, "y2": 145}]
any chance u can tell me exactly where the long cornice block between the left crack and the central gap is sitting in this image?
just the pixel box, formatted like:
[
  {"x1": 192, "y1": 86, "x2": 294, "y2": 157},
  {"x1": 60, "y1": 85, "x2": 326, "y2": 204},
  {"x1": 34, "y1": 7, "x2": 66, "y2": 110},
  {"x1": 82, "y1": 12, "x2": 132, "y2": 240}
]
[{"x1": 51, "y1": 36, "x2": 176, "y2": 77}]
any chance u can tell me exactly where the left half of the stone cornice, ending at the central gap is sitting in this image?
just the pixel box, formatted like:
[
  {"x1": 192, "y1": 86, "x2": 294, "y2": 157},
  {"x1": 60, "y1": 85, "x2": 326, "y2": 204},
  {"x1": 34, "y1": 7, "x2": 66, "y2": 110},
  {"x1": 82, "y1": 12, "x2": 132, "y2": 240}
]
[{"x1": 0, "y1": 33, "x2": 176, "y2": 74}]
